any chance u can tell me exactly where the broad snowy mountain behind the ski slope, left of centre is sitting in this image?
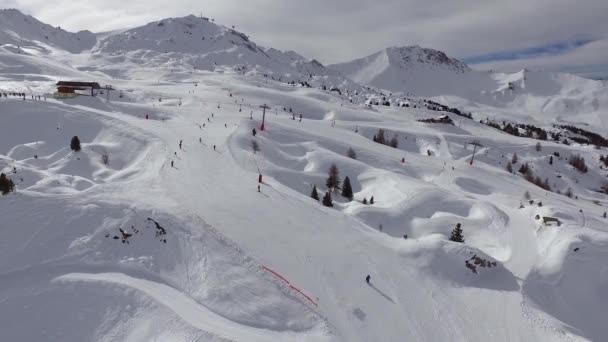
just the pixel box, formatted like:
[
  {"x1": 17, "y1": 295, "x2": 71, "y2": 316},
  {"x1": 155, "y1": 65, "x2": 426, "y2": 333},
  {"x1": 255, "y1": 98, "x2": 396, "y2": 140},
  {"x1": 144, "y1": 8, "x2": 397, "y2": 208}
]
[{"x1": 92, "y1": 15, "x2": 343, "y2": 81}]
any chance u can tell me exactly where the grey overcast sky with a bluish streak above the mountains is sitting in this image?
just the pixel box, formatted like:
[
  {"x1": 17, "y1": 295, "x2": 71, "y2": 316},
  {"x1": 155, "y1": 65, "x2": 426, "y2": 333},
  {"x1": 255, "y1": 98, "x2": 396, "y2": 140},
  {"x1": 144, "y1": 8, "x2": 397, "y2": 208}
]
[{"x1": 0, "y1": 0, "x2": 608, "y2": 78}]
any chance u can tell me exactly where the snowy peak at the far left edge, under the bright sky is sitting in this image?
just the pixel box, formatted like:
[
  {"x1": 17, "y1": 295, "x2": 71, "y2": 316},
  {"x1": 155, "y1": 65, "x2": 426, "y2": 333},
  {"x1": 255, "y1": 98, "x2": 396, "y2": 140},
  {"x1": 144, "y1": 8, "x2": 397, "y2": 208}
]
[{"x1": 0, "y1": 9, "x2": 96, "y2": 54}]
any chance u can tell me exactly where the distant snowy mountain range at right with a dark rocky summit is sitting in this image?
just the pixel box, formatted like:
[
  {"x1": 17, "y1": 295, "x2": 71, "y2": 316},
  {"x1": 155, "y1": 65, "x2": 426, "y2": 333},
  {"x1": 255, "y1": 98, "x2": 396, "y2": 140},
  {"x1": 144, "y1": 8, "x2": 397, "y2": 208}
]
[{"x1": 328, "y1": 46, "x2": 608, "y2": 127}]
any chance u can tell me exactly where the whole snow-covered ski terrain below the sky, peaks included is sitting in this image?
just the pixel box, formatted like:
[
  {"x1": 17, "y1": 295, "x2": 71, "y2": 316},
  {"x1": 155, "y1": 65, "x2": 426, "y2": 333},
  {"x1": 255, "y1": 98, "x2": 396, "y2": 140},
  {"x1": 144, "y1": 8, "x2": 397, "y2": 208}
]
[{"x1": 0, "y1": 10, "x2": 608, "y2": 342}]
